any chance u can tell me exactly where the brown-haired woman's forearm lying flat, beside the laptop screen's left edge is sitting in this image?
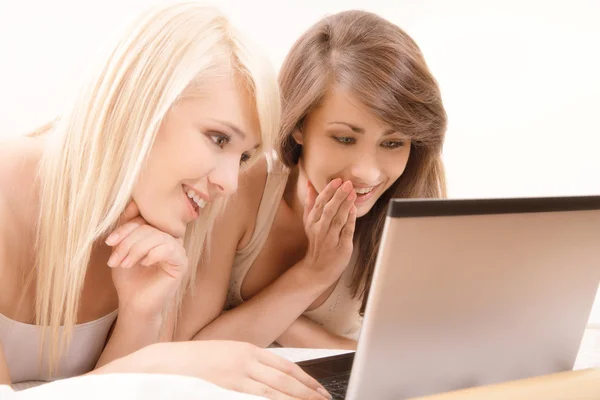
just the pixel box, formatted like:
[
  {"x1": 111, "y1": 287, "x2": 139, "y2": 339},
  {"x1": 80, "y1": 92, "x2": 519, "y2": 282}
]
[{"x1": 277, "y1": 315, "x2": 356, "y2": 350}]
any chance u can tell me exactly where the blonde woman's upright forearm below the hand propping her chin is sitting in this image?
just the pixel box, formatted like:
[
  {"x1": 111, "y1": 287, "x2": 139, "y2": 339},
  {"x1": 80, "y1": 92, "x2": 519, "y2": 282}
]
[{"x1": 96, "y1": 315, "x2": 163, "y2": 368}]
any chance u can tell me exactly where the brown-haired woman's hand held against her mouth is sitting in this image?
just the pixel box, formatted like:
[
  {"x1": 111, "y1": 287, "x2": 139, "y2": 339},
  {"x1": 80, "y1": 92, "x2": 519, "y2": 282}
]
[{"x1": 303, "y1": 178, "x2": 356, "y2": 280}]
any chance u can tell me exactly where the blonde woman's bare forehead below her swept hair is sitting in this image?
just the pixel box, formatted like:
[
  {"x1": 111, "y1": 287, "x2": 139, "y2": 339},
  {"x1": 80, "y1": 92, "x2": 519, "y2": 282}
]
[{"x1": 183, "y1": 76, "x2": 260, "y2": 143}]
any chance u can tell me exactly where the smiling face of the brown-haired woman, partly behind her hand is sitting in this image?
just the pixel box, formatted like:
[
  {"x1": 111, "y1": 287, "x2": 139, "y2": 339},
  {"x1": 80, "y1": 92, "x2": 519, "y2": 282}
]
[{"x1": 294, "y1": 89, "x2": 411, "y2": 217}]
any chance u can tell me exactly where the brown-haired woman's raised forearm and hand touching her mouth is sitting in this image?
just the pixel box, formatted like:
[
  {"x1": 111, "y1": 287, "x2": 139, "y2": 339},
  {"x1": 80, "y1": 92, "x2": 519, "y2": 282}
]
[{"x1": 188, "y1": 180, "x2": 355, "y2": 347}]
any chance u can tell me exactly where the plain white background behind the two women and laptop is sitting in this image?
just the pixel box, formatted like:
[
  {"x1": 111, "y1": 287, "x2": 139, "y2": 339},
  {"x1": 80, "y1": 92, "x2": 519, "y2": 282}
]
[{"x1": 0, "y1": 0, "x2": 600, "y2": 322}]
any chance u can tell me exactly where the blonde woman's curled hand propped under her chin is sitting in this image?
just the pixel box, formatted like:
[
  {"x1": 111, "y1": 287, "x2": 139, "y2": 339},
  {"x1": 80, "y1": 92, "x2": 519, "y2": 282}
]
[{"x1": 106, "y1": 201, "x2": 188, "y2": 317}]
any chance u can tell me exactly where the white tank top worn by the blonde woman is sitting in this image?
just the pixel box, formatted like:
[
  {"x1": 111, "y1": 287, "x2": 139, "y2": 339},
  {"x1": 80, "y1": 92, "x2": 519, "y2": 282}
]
[{"x1": 0, "y1": 310, "x2": 118, "y2": 384}]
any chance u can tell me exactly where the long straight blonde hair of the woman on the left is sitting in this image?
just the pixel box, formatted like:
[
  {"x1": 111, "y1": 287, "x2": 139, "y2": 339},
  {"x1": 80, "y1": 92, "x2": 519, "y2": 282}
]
[{"x1": 34, "y1": 1, "x2": 280, "y2": 374}]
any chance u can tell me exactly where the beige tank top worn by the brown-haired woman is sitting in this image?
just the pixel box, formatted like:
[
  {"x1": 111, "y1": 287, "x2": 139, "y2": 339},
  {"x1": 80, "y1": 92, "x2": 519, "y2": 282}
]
[{"x1": 225, "y1": 153, "x2": 362, "y2": 340}]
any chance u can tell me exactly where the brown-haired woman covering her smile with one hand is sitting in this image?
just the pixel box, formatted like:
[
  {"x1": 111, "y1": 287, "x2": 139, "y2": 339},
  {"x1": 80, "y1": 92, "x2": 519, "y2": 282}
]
[{"x1": 176, "y1": 10, "x2": 446, "y2": 349}]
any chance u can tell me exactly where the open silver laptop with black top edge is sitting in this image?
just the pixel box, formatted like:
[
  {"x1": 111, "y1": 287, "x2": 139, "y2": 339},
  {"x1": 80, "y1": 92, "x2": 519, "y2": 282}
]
[{"x1": 298, "y1": 196, "x2": 600, "y2": 400}]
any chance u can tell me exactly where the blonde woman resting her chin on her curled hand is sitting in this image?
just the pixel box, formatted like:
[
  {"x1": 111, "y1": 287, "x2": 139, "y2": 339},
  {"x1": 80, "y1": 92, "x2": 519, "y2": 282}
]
[{"x1": 0, "y1": 2, "x2": 325, "y2": 399}]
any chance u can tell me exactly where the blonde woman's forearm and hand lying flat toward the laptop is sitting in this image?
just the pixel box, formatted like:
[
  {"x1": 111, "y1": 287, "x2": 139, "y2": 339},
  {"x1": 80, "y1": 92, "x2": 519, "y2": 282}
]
[{"x1": 118, "y1": 340, "x2": 331, "y2": 400}]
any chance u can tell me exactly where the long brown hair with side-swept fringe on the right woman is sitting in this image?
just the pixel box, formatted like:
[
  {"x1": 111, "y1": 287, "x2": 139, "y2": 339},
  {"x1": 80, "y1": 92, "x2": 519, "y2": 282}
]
[{"x1": 276, "y1": 10, "x2": 447, "y2": 314}]
